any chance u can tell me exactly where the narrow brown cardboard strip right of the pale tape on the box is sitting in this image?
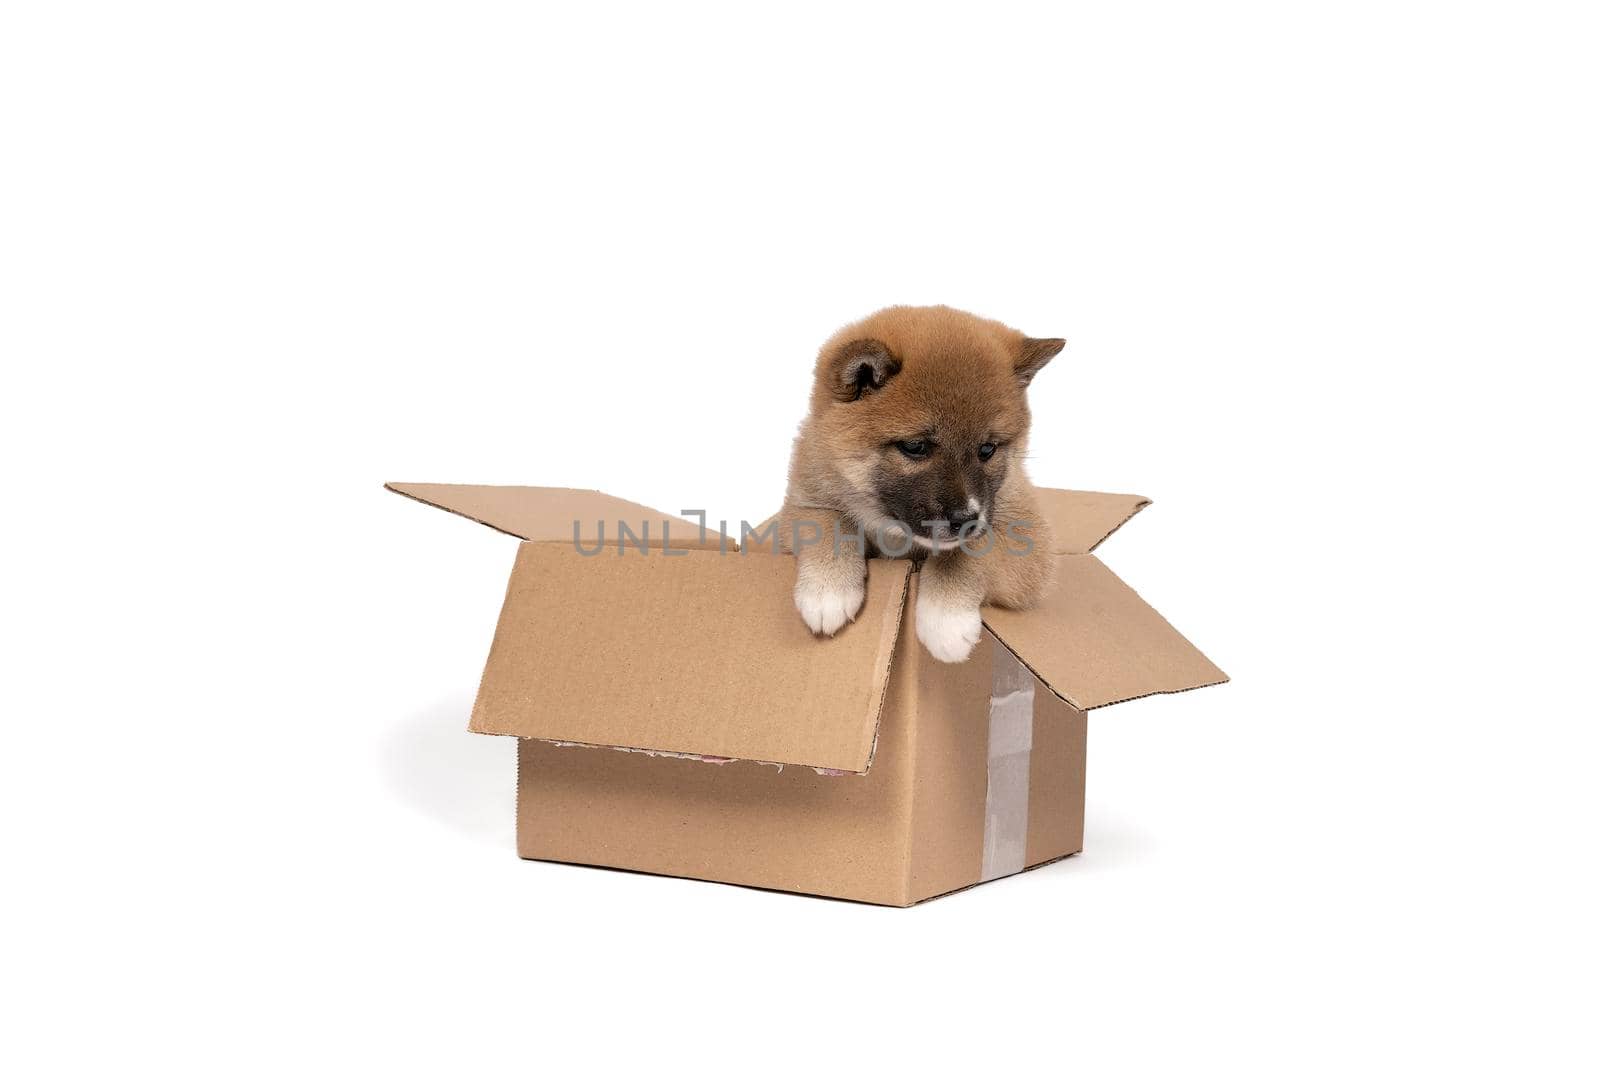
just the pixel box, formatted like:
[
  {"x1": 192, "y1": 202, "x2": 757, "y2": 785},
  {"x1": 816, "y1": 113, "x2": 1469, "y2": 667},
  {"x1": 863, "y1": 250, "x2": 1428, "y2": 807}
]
[{"x1": 1026, "y1": 686, "x2": 1090, "y2": 867}]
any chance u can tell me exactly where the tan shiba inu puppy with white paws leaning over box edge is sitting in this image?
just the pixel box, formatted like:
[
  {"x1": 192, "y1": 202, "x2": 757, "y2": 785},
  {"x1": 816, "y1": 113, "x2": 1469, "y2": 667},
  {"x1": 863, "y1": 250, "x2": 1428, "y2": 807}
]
[{"x1": 778, "y1": 307, "x2": 1066, "y2": 662}]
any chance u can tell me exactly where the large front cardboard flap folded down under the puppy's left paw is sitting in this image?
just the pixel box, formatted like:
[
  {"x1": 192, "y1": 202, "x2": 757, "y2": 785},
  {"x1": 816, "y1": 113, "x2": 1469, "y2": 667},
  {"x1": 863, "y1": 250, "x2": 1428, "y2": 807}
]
[{"x1": 470, "y1": 542, "x2": 910, "y2": 773}]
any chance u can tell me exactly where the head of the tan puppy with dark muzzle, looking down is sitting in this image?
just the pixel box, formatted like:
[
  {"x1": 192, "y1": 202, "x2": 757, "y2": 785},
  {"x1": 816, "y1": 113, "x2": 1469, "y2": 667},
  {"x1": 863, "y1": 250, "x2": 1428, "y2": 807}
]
[{"x1": 811, "y1": 307, "x2": 1066, "y2": 550}]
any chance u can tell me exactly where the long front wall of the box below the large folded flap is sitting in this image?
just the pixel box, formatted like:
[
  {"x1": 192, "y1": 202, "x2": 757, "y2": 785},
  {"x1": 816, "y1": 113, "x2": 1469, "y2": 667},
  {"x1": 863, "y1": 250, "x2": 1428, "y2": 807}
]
[{"x1": 517, "y1": 662, "x2": 912, "y2": 905}]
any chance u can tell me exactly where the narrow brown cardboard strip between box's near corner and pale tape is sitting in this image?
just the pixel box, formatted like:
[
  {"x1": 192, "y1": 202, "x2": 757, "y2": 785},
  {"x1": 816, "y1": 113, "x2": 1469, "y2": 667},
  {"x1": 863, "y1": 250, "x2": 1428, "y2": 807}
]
[{"x1": 898, "y1": 620, "x2": 998, "y2": 901}]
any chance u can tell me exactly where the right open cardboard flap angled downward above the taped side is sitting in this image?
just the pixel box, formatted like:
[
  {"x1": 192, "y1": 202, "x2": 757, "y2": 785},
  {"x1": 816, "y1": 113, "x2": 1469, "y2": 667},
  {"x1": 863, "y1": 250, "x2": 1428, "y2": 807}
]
[{"x1": 982, "y1": 555, "x2": 1227, "y2": 710}]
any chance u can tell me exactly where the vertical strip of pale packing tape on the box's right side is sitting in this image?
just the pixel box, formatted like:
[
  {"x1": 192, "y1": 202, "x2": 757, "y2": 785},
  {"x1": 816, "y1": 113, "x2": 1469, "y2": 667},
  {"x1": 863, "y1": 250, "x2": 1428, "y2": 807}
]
[{"x1": 982, "y1": 640, "x2": 1034, "y2": 881}]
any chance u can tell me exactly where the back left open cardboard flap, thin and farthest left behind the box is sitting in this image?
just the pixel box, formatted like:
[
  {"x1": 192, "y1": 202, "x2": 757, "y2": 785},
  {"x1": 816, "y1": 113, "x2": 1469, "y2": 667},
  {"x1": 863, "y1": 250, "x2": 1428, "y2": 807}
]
[{"x1": 384, "y1": 482, "x2": 733, "y2": 549}]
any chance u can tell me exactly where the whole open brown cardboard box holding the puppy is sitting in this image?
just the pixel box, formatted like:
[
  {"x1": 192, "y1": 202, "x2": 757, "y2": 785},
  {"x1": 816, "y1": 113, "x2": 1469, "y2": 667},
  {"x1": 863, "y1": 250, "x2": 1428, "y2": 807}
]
[{"x1": 387, "y1": 483, "x2": 1227, "y2": 905}]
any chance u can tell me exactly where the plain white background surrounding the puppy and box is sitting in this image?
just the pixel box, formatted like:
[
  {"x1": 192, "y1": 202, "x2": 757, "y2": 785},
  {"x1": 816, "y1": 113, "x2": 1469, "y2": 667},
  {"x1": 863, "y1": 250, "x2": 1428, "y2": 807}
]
[{"x1": 0, "y1": 3, "x2": 1600, "y2": 1064}]
